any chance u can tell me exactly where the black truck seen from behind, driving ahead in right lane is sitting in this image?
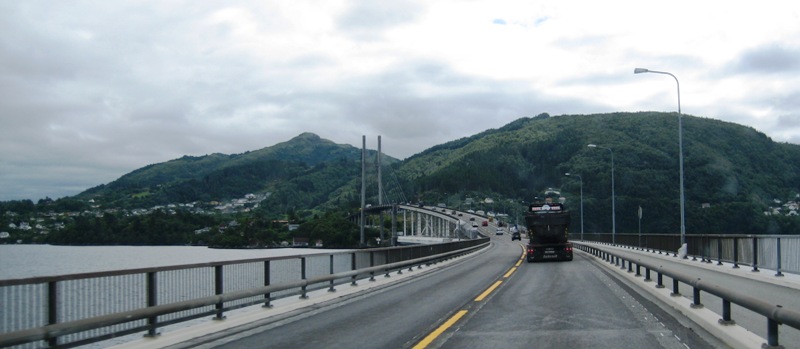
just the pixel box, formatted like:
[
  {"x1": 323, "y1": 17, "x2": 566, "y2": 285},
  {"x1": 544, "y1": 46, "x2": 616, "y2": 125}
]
[{"x1": 525, "y1": 203, "x2": 572, "y2": 262}]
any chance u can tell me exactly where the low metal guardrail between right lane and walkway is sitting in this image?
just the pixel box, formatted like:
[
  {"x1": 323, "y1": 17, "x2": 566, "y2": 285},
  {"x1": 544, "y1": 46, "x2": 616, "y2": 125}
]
[{"x1": 573, "y1": 242, "x2": 800, "y2": 348}]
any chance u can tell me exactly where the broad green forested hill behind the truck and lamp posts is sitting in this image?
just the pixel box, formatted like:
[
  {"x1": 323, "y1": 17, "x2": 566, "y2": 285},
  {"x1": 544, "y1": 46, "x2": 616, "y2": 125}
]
[{"x1": 397, "y1": 112, "x2": 800, "y2": 233}]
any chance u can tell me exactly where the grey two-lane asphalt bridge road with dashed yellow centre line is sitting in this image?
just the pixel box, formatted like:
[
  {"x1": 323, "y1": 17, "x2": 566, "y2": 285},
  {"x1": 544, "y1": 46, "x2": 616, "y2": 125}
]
[{"x1": 177, "y1": 235, "x2": 719, "y2": 348}]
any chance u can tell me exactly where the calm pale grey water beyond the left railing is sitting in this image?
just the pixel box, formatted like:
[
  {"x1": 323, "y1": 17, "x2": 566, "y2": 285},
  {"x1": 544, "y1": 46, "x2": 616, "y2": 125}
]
[{"x1": 0, "y1": 245, "x2": 350, "y2": 280}]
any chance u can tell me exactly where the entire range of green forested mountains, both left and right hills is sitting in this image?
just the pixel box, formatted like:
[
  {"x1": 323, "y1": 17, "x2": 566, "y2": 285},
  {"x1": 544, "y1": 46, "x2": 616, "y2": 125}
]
[{"x1": 0, "y1": 112, "x2": 800, "y2": 244}]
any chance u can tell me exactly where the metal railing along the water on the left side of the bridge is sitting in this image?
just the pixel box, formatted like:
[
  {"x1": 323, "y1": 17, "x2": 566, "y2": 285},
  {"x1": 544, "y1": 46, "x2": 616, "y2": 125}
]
[{"x1": 0, "y1": 238, "x2": 489, "y2": 348}]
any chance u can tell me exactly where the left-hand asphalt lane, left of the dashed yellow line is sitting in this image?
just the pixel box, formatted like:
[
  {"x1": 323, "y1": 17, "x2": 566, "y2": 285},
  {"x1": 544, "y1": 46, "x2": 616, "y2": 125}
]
[{"x1": 174, "y1": 231, "x2": 522, "y2": 348}]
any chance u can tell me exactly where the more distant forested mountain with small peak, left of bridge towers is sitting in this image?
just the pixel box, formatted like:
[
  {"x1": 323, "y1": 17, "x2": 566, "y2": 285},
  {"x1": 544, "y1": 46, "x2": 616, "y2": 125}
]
[{"x1": 76, "y1": 133, "x2": 397, "y2": 212}]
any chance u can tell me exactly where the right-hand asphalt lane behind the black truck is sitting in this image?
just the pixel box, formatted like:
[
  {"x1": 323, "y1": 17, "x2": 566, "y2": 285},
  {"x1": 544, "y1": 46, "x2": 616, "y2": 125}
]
[{"x1": 431, "y1": 247, "x2": 721, "y2": 349}]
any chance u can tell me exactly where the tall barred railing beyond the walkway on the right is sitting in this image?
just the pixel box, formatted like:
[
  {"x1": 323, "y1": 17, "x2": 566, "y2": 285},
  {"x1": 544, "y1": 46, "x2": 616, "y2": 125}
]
[{"x1": 570, "y1": 233, "x2": 800, "y2": 276}]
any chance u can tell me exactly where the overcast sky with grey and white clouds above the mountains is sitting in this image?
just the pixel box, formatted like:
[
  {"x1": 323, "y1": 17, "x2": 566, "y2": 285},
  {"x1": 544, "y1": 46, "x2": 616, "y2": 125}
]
[{"x1": 0, "y1": 0, "x2": 800, "y2": 202}]
